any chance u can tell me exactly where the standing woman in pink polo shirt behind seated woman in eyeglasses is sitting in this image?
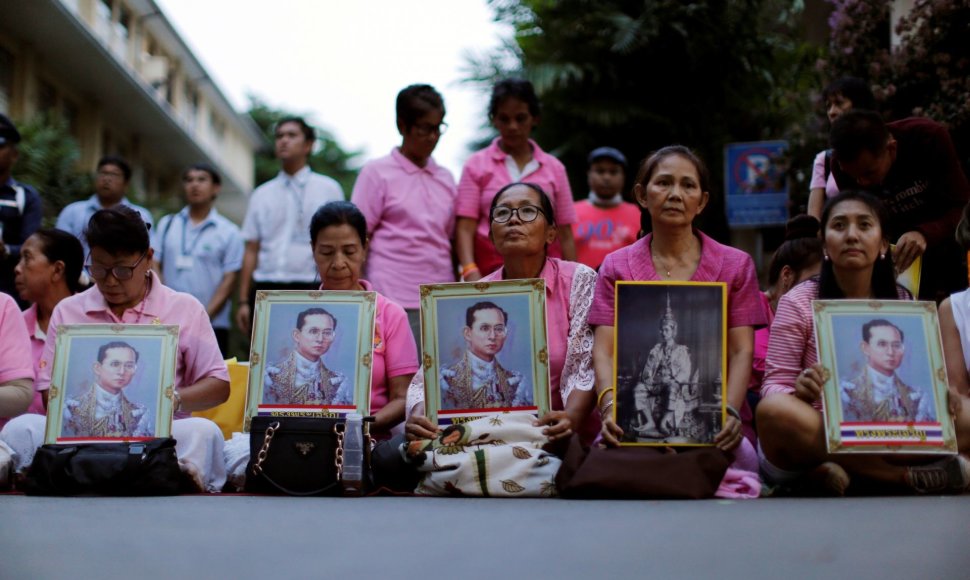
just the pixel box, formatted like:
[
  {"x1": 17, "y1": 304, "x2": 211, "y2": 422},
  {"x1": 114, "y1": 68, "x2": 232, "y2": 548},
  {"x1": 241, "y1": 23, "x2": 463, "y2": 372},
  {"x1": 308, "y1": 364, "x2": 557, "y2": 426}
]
[{"x1": 455, "y1": 79, "x2": 576, "y2": 281}]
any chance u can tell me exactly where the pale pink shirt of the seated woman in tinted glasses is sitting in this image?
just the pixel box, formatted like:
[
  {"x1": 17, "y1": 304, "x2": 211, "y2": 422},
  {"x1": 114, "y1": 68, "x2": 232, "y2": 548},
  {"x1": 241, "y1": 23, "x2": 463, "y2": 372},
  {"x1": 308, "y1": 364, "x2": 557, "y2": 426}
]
[{"x1": 37, "y1": 272, "x2": 229, "y2": 419}]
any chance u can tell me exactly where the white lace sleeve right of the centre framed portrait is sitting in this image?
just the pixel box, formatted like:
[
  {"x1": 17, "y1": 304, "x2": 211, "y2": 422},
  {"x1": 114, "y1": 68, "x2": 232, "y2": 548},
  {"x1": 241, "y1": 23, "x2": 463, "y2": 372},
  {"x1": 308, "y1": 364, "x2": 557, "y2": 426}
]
[{"x1": 559, "y1": 264, "x2": 596, "y2": 405}]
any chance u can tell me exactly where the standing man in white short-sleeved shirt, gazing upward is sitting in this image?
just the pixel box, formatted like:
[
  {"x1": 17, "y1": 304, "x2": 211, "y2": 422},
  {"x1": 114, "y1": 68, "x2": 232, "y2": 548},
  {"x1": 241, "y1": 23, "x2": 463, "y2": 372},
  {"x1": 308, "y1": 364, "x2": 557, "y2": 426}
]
[{"x1": 236, "y1": 117, "x2": 344, "y2": 335}]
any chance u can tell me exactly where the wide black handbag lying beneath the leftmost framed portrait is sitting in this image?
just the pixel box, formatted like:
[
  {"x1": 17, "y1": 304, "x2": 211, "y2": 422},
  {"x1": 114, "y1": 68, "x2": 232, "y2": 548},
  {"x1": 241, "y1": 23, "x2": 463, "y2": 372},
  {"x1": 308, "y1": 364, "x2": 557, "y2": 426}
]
[{"x1": 23, "y1": 437, "x2": 186, "y2": 495}]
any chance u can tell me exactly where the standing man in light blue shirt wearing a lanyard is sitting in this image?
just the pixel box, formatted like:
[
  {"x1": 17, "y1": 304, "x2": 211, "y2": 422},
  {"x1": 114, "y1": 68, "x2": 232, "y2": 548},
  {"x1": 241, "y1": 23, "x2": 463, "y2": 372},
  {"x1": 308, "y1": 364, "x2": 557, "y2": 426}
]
[{"x1": 152, "y1": 163, "x2": 243, "y2": 357}]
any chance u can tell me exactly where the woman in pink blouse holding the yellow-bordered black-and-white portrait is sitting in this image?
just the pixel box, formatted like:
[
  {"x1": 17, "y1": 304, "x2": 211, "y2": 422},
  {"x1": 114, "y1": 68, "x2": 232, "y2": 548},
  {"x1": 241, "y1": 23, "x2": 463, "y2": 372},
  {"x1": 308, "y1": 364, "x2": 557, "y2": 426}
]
[{"x1": 589, "y1": 145, "x2": 766, "y2": 462}]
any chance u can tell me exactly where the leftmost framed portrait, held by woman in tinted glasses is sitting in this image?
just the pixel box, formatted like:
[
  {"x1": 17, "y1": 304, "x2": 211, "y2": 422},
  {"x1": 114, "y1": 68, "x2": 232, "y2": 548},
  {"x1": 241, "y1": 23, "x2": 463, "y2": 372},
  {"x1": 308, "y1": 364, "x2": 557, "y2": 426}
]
[{"x1": 44, "y1": 324, "x2": 179, "y2": 443}]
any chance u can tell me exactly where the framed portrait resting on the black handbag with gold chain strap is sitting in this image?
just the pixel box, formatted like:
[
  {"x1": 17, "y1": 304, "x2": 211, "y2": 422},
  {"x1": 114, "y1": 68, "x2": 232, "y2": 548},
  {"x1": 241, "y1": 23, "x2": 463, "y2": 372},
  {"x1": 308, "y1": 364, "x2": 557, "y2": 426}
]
[{"x1": 245, "y1": 290, "x2": 377, "y2": 430}]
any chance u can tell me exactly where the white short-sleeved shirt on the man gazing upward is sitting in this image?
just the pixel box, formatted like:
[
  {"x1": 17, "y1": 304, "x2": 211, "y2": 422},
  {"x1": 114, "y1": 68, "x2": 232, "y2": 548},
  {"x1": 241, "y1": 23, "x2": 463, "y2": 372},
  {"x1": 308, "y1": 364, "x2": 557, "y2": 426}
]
[{"x1": 242, "y1": 166, "x2": 344, "y2": 282}]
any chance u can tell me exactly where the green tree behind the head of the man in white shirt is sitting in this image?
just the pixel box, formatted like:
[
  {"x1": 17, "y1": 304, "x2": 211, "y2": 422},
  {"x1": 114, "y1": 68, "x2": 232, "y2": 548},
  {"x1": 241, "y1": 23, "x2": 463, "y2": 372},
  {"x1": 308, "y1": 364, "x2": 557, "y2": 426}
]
[{"x1": 248, "y1": 95, "x2": 361, "y2": 198}]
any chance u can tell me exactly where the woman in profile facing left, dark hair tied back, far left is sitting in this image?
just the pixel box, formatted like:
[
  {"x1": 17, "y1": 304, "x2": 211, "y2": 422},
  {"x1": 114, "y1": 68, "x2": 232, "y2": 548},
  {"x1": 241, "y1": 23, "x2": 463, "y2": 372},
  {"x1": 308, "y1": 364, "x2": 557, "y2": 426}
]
[{"x1": 11, "y1": 229, "x2": 84, "y2": 426}]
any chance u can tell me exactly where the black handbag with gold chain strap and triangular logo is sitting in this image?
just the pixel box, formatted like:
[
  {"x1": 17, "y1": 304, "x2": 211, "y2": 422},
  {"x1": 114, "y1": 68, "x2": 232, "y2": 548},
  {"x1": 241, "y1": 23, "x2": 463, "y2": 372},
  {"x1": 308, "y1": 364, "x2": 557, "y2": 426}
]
[{"x1": 245, "y1": 416, "x2": 370, "y2": 496}]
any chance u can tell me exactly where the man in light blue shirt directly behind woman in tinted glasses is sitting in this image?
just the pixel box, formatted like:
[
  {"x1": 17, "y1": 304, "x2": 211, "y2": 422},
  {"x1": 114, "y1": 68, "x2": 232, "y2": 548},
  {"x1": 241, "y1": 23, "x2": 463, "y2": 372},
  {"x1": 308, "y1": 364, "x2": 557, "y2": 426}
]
[{"x1": 57, "y1": 155, "x2": 152, "y2": 259}]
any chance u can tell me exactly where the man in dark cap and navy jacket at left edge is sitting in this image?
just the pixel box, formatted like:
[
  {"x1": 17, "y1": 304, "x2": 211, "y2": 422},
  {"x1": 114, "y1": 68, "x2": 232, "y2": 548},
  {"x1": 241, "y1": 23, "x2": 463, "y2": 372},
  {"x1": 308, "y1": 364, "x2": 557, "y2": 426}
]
[{"x1": 0, "y1": 115, "x2": 41, "y2": 306}]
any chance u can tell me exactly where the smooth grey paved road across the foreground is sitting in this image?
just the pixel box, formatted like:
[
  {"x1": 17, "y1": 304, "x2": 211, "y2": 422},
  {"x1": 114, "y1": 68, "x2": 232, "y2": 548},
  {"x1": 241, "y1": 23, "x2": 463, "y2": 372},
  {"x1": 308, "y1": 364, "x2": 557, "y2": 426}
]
[{"x1": 0, "y1": 496, "x2": 970, "y2": 580}]
